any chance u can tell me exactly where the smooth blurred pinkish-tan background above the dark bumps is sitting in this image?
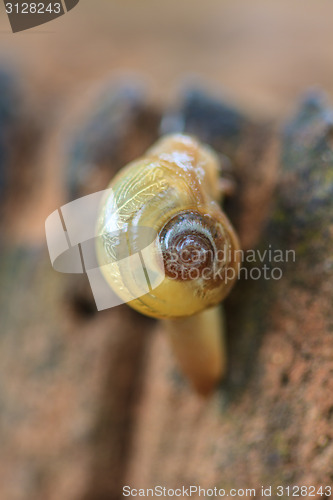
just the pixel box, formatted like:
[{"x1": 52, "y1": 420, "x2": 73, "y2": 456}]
[{"x1": 0, "y1": 0, "x2": 333, "y2": 242}]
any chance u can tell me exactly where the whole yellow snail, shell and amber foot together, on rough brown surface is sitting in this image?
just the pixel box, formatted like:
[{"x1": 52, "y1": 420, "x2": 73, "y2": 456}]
[{"x1": 96, "y1": 134, "x2": 239, "y2": 394}]
